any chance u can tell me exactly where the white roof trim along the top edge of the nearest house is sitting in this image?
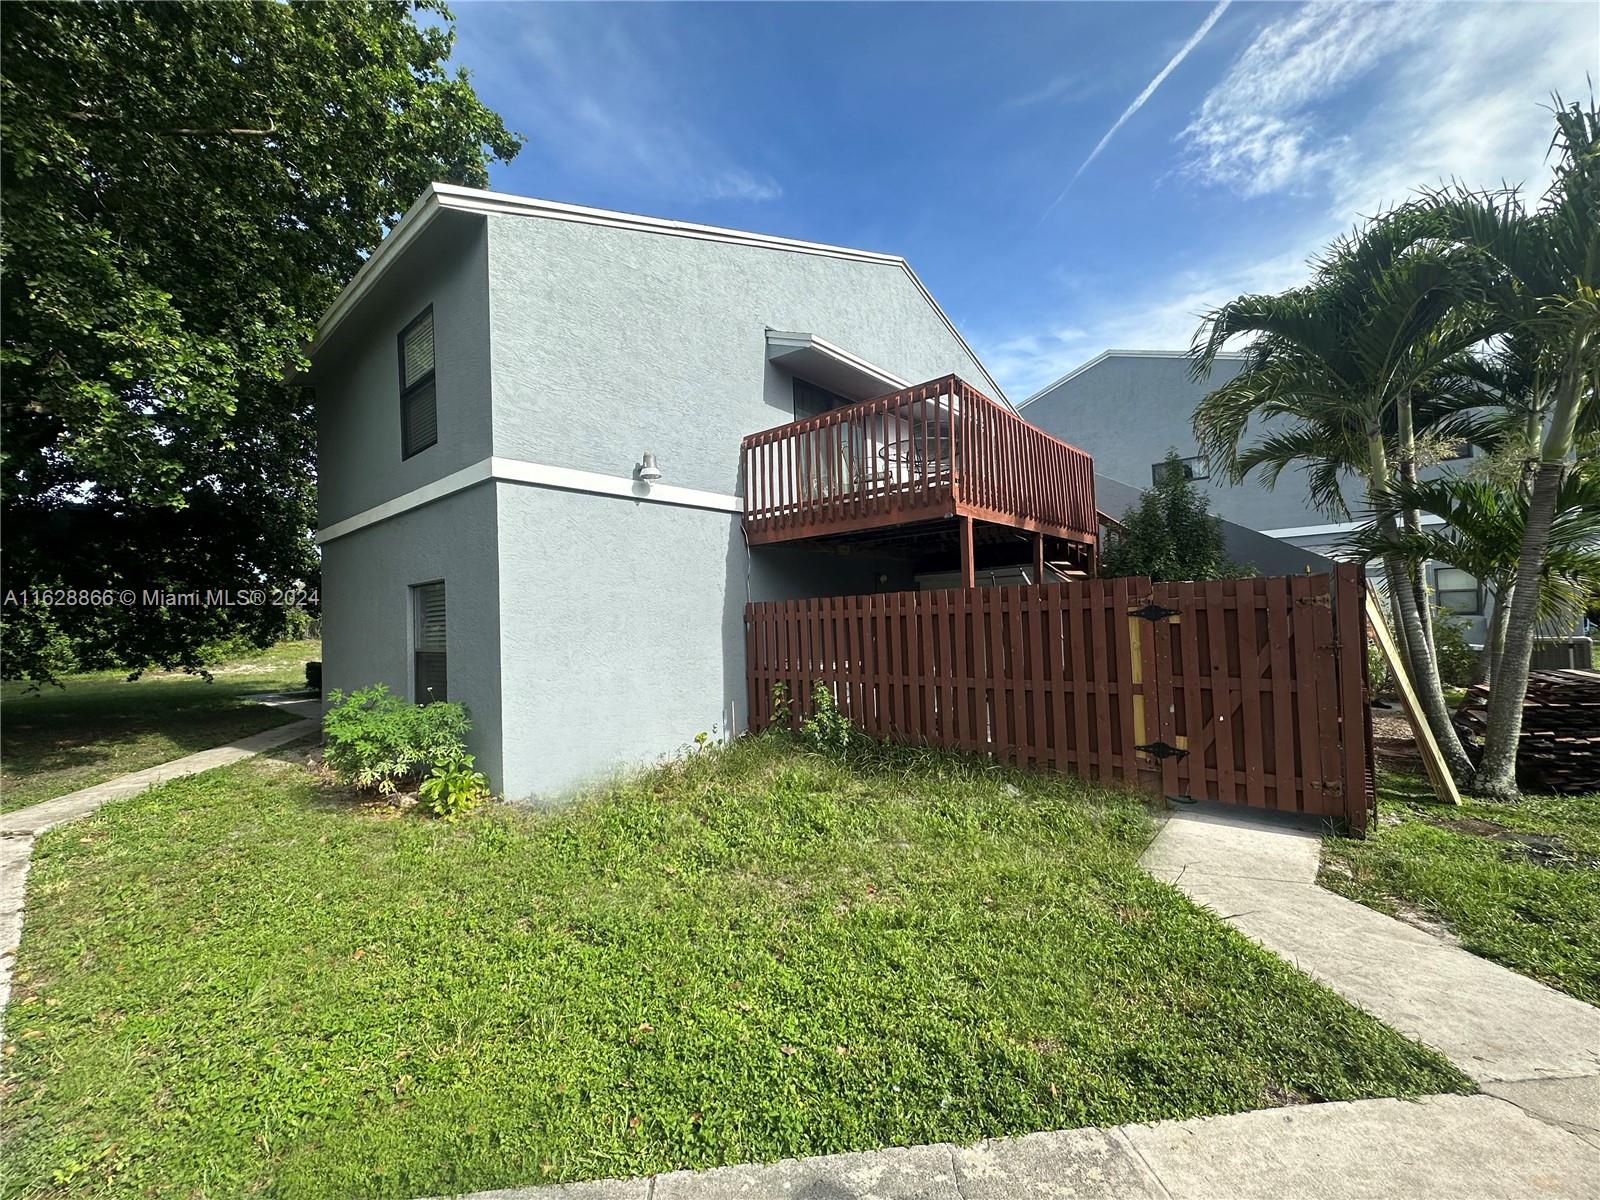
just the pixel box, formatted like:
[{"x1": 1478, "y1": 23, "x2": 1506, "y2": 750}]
[{"x1": 310, "y1": 184, "x2": 1011, "y2": 405}]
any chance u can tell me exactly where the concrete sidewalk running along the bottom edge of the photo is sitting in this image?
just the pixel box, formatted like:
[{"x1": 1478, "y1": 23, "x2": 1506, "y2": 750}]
[{"x1": 448, "y1": 1096, "x2": 1600, "y2": 1200}]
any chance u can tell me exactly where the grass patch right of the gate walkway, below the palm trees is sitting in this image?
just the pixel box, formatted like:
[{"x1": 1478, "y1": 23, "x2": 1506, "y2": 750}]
[{"x1": 1320, "y1": 774, "x2": 1600, "y2": 1003}]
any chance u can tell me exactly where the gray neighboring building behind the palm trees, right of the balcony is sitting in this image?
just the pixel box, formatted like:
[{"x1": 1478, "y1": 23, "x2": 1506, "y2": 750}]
[{"x1": 1018, "y1": 350, "x2": 1491, "y2": 643}]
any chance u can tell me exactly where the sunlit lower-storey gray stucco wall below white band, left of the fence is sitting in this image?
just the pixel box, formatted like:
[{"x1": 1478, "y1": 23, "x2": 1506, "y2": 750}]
[{"x1": 496, "y1": 483, "x2": 912, "y2": 800}]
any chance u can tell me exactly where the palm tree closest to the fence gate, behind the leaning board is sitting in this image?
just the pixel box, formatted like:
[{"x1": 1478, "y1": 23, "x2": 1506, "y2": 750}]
[{"x1": 1192, "y1": 232, "x2": 1490, "y2": 782}]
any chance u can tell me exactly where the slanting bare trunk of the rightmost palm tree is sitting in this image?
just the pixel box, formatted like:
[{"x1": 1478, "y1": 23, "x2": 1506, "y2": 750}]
[{"x1": 1475, "y1": 338, "x2": 1587, "y2": 798}]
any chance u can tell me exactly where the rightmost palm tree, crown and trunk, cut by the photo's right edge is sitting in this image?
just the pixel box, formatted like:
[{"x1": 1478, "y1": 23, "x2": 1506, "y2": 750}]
[{"x1": 1419, "y1": 98, "x2": 1600, "y2": 797}]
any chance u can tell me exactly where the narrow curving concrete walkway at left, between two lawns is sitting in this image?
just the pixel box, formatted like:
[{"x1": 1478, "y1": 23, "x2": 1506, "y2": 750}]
[{"x1": 0, "y1": 718, "x2": 320, "y2": 1035}]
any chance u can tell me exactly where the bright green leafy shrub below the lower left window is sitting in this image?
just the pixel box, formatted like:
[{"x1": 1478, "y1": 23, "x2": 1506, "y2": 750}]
[{"x1": 322, "y1": 683, "x2": 472, "y2": 795}]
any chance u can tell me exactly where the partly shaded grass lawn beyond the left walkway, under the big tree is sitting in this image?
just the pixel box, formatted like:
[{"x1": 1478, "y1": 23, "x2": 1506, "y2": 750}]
[{"x1": 0, "y1": 642, "x2": 322, "y2": 813}]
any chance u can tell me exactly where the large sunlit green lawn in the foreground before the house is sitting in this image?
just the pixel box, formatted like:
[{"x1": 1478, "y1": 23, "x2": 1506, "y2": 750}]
[{"x1": 0, "y1": 739, "x2": 1469, "y2": 1197}]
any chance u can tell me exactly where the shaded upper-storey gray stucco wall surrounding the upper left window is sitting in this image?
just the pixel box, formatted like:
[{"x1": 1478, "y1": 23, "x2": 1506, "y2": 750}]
[{"x1": 312, "y1": 214, "x2": 491, "y2": 528}]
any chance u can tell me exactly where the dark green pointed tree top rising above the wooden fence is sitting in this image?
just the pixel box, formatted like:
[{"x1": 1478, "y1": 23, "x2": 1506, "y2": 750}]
[{"x1": 1101, "y1": 450, "x2": 1242, "y2": 581}]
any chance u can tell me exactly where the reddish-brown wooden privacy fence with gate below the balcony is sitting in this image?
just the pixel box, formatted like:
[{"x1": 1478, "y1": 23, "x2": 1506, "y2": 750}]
[{"x1": 746, "y1": 566, "x2": 1373, "y2": 832}]
